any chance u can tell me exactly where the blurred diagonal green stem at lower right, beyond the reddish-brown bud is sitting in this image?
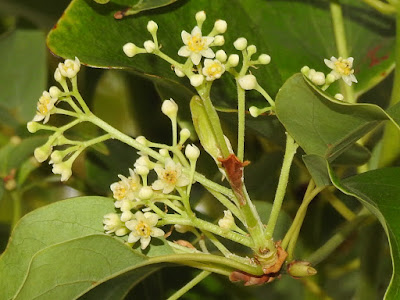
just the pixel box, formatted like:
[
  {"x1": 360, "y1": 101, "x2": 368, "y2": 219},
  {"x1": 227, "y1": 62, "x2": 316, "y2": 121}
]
[{"x1": 306, "y1": 207, "x2": 372, "y2": 265}]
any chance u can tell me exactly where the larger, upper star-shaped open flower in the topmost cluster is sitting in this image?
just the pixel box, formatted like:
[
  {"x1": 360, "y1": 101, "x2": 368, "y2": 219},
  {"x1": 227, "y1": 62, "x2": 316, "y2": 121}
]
[{"x1": 178, "y1": 26, "x2": 215, "y2": 65}]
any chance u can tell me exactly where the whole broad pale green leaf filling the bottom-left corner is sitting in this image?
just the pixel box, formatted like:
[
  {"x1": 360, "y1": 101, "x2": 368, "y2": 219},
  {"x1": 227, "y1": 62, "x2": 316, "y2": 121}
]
[{"x1": 0, "y1": 197, "x2": 172, "y2": 299}]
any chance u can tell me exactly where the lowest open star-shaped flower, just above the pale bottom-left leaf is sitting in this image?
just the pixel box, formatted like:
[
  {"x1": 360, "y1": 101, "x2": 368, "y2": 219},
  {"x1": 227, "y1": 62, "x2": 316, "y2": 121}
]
[{"x1": 125, "y1": 211, "x2": 164, "y2": 250}]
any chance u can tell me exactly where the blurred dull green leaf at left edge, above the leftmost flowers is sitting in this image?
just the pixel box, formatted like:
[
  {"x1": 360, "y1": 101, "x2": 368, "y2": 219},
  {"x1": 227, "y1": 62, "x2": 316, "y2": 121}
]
[{"x1": 0, "y1": 30, "x2": 47, "y2": 123}]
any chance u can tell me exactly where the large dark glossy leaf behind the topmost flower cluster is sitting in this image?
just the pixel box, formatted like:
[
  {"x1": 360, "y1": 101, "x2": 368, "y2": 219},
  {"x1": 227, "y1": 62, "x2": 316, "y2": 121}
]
[{"x1": 48, "y1": 0, "x2": 394, "y2": 101}]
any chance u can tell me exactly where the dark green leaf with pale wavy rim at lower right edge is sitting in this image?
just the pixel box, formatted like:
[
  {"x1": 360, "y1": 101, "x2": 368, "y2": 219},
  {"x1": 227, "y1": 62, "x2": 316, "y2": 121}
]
[{"x1": 329, "y1": 168, "x2": 400, "y2": 300}]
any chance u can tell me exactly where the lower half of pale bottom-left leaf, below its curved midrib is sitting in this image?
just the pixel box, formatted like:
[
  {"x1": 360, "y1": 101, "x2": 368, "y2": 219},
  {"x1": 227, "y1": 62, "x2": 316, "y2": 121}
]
[{"x1": 15, "y1": 235, "x2": 161, "y2": 299}]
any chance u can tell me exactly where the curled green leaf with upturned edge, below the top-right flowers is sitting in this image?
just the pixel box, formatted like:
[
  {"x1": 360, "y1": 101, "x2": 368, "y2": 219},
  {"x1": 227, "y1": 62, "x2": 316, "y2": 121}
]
[{"x1": 276, "y1": 74, "x2": 398, "y2": 162}]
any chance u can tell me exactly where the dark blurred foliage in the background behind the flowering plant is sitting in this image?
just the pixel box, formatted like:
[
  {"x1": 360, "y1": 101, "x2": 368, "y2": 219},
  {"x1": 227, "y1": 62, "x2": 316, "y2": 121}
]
[{"x1": 0, "y1": 0, "x2": 394, "y2": 300}]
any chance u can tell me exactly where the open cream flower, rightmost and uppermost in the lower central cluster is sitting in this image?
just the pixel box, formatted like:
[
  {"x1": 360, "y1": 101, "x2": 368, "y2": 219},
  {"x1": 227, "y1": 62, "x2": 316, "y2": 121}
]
[{"x1": 152, "y1": 158, "x2": 190, "y2": 194}]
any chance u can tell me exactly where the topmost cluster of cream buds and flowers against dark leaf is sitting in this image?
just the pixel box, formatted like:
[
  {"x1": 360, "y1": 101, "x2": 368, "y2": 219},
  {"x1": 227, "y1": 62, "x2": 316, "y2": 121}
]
[{"x1": 123, "y1": 11, "x2": 271, "y2": 90}]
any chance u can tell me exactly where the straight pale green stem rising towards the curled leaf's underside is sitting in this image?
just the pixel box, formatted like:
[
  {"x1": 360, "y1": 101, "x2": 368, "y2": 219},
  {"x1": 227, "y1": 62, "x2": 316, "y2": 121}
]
[{"x1": 266, "y1": 133, "x2": 298, "y2": 239}]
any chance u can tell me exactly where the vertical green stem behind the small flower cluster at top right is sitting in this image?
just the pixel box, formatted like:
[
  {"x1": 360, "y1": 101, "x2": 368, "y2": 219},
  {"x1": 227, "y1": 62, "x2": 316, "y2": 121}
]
[{"x1": 330, "y1": 0, "x2": 356, "y2": 103}]
